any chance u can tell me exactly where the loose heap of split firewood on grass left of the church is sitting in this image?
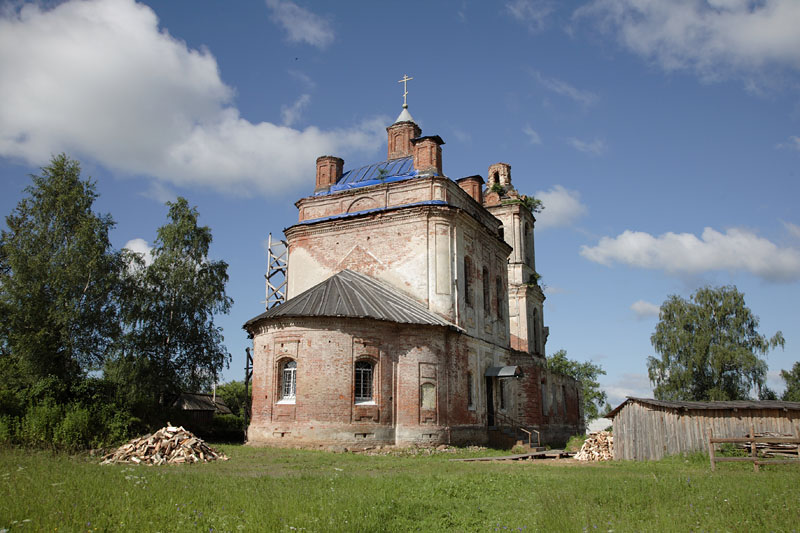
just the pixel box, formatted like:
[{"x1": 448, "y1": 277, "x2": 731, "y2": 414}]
[{"x1": 100, "y1": 425, "x2": 228, "y2": 465}]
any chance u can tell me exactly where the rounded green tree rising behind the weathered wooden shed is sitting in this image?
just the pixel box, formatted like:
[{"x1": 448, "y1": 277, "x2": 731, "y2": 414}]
[{"x1": 647, "y1": 286, "x2": 784, "y2": 401}]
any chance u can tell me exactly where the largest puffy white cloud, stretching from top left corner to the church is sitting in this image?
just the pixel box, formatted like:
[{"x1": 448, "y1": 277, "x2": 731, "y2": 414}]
[{"x1": 0, "y1": 0, "x2": 388, "y2": 195}]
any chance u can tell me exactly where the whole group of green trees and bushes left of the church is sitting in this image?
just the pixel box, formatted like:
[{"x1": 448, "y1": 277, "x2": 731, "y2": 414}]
[{"x1": 0, "y1": 154, "x2": 233, "y2": 448}]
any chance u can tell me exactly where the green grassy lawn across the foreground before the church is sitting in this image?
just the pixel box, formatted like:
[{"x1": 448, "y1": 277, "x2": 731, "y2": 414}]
[{"x1": 0, "y1": 446, "x2": 800, "y2": 532}]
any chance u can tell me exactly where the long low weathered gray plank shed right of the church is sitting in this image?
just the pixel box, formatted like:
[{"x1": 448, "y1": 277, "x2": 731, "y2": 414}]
[{"x1": 606, "y1": 397, "x2": 800, "y2": 460}]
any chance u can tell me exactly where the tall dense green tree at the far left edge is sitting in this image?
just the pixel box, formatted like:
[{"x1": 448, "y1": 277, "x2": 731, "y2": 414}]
[{"x1": 0, "y1": 154, "x2": 122, "y2": 397}]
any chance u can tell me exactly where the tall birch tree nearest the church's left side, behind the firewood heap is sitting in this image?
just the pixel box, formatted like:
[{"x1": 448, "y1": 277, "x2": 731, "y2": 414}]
[{"x1": 115, "y1": 197, "x2": 233, "y2": 405}]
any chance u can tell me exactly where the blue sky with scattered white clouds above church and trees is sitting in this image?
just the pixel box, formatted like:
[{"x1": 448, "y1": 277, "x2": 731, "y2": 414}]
[{"x1": 0, "y1": 0, "x2": 800, "y2": 405}]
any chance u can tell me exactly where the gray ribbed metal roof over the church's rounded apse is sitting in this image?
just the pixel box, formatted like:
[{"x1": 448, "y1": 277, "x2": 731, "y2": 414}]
[{"x1": 243, "y1": 270, "x2": 459, "y2": 329}]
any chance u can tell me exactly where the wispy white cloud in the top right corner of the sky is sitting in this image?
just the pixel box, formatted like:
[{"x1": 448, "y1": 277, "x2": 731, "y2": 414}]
[{"x1": 574, "y1": 0, "x2": 800, "y2": 83}]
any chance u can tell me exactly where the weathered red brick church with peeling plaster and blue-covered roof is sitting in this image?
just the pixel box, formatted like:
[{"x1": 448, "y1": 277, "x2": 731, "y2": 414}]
[{"x1": 244, "y1": 90, "x2": 584, "y2": 447}]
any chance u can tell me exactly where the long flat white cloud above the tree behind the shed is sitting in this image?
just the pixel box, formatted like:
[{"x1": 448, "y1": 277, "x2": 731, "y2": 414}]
[{"x1": 580, "y1": 228, "x2": 800, "y2": 282}]
